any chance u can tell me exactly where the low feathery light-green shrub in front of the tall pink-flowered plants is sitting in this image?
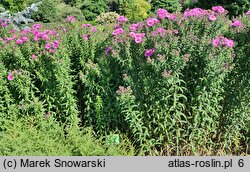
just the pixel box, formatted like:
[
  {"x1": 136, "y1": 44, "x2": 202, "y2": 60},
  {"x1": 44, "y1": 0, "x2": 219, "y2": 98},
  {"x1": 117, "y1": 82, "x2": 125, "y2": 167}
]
[{"x1": 0, "y1": 118, "x2": 133, "y2": 156}]
